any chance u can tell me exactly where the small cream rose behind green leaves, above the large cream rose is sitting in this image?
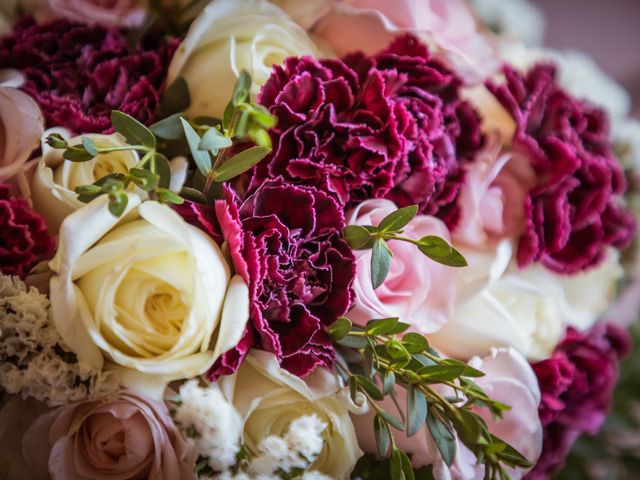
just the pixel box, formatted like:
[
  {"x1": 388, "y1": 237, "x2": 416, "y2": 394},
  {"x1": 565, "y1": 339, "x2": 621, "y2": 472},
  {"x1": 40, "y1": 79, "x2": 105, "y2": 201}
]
[{"x1": 31, "y1": 128, "x2": 187, "y2": 233}]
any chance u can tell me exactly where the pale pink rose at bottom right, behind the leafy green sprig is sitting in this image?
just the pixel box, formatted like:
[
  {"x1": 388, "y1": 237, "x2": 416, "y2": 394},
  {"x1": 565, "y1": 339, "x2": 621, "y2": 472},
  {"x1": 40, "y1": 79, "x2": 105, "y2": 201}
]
[{"x1": 351, "y1": 349, "x2": 542, "y2": 480}]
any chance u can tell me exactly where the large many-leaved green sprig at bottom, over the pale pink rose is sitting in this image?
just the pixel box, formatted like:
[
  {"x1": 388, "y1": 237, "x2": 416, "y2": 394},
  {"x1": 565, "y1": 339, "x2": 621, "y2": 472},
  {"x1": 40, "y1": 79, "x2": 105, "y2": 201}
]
[{"x1": 329, "y1": 317, "x2": 530, "y2": 480}]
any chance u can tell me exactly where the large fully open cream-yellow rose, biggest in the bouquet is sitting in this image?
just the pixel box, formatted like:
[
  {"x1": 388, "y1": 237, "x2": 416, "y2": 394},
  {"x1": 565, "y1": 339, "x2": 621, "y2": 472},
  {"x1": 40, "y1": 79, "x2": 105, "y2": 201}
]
[{"x1": 50, "y1": 194, "x2": 249, "y2": 398}]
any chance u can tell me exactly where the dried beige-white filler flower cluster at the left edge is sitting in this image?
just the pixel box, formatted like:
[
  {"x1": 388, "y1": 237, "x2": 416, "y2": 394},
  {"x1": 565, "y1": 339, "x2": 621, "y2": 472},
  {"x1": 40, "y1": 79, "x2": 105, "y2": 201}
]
[{"x1": 0, "y1": 275, "x2": 118, "y2": 405}]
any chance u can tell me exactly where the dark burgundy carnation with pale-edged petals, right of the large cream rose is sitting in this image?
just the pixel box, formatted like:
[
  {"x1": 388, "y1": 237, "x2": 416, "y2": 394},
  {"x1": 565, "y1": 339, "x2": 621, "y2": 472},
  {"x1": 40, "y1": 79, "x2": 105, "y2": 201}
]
[{"x1": 177, "y1": 181, "x2": 355, "y2": 378}]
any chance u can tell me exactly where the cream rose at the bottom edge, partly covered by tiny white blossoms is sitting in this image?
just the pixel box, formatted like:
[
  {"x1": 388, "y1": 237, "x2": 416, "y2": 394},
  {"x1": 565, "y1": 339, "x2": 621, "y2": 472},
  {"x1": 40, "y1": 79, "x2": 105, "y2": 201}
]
[{"x1": 218, "y1": 350, "x2": 362, "y2": 480}]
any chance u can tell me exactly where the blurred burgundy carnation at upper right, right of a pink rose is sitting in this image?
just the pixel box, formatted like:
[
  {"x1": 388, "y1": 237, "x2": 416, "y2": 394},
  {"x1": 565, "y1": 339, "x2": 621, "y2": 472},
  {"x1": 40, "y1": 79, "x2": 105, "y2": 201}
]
[{"x1": 488, "y1": 65, "x2": 635, "y2": 273}]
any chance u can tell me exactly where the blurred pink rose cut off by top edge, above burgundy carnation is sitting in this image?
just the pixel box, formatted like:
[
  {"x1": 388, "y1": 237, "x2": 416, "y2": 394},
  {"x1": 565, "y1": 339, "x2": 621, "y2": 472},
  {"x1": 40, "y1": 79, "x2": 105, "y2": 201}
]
[{"x1": 49, "y1": 0, "x2": 147, "y2": 28}]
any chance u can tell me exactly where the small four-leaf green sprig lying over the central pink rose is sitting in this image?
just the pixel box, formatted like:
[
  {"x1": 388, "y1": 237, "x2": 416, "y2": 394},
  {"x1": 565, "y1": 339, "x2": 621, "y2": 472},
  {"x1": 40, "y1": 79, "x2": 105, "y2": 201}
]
[{"x1": 344, "y1": 205, "x2": 467, "y2": 288}]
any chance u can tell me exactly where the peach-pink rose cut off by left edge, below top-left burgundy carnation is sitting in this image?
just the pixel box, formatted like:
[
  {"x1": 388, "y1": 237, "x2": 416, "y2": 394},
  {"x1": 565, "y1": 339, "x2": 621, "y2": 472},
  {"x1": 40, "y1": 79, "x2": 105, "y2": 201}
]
[{"x1": 0, "y1": 86, "x2": 44, "y2": 197}]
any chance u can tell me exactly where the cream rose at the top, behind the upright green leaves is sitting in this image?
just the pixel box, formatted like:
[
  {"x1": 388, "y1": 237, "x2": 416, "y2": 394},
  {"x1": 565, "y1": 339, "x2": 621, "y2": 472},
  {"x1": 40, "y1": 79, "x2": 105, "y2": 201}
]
[{"x1": 167, "y1": 0, "x2": 317, "y2": 117}]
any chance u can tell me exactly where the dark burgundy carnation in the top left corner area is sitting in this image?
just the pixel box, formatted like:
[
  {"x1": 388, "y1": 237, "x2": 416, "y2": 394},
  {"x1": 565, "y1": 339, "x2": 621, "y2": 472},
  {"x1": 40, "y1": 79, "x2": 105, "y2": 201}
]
[{"x1": 0, "y1": 18, "x2": 178, "y2": 133}]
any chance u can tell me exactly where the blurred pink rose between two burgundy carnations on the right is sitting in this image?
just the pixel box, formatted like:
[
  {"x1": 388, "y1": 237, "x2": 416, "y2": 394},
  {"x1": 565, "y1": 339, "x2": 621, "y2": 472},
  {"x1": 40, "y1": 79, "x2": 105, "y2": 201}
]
[{"x1": 453, "y1": 135, "x2": 535, "y2": 248}]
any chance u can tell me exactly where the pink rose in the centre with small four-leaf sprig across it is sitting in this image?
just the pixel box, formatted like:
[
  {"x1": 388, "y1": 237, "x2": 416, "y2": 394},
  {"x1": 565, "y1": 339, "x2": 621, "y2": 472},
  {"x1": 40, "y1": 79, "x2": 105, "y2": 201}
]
[{"x1": 347, "y1": 199, "x2": 456, "y2": 333}]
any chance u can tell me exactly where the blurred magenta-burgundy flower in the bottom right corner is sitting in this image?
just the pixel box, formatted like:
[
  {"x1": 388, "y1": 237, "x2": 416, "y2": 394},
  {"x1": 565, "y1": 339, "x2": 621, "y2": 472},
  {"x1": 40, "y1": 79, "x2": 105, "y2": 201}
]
[{"x1": 527, "y1": 324, "x2": 631, "y2": 480}]
